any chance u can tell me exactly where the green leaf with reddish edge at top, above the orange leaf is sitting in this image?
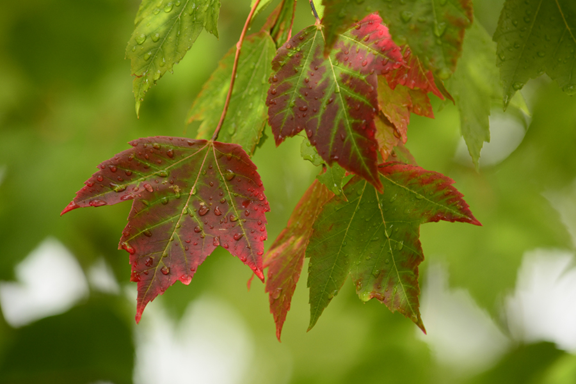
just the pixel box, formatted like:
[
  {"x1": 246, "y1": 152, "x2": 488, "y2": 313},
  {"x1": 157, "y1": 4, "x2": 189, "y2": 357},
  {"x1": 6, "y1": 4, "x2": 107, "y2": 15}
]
[{"x1": 322, "y1": 0, "x2": 472, "y2": 79}]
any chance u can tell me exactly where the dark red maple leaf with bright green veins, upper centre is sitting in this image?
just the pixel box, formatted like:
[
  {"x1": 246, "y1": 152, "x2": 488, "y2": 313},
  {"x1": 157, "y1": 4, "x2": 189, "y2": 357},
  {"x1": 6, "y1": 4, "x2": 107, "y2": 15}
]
[{"x1": 267, "y1": 14, "x2": 402, "y2": 188}]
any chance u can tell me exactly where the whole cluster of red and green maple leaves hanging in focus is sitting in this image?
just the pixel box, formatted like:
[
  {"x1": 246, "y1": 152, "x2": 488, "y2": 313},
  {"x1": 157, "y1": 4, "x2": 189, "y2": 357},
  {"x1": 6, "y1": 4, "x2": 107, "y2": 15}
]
[{"x1": 63, "y1": 0, "x2": 576, "y2": 338}]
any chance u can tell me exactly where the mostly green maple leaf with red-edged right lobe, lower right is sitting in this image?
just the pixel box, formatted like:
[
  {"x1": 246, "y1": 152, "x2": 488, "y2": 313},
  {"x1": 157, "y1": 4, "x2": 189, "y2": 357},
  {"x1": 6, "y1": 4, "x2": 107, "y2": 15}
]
[{"x1": 306, "y1": 162, "x2": 480, "y2": 331}]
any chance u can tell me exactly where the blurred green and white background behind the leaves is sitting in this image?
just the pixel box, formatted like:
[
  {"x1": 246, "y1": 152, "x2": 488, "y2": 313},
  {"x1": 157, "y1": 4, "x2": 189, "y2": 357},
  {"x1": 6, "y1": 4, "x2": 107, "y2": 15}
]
[{"x1": 0, "y1": 0, "x2": 576, "y2": 384}]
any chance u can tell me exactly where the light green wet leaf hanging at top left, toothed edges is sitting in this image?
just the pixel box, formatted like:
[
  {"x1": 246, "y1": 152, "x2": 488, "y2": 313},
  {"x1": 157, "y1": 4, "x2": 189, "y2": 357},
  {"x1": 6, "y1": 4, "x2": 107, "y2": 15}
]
[{"x1": 126, "y1": 0, "x2": 220, "y2": 114}]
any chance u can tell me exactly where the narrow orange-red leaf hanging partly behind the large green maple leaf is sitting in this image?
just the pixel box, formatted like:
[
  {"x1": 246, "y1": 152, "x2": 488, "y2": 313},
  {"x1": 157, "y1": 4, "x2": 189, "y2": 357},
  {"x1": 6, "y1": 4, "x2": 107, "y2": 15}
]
[{"x1": 264, "y1": 180, "x2": 334, "y2": 340}]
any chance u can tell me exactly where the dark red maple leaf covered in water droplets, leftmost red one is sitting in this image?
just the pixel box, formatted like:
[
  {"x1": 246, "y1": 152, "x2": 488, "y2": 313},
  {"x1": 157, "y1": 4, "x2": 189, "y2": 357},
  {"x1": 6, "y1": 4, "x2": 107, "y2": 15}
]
[{"x1": 62, "y1": 136, "x2": 269, "y2": 322}]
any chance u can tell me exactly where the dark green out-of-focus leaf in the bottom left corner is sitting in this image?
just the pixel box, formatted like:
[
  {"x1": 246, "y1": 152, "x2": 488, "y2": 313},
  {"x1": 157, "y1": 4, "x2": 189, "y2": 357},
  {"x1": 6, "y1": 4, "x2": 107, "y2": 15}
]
[{"x1": 0, "y1": 297, "x2": 134, "y2": 384}]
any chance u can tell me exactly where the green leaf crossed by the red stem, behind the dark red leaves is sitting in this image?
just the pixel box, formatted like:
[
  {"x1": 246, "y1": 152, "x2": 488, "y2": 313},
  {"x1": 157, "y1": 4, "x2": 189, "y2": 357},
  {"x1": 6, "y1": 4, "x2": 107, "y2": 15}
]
[{"x1": 188, "y1": 31, "x2": 276, "y2": 155}]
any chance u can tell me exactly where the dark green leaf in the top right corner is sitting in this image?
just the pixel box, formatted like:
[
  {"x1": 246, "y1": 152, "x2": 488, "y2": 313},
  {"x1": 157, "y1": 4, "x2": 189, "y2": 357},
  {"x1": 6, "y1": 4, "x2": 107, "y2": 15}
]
[{"x1": 494, "y1": 0, "x2": 576, "y2": 105}]
